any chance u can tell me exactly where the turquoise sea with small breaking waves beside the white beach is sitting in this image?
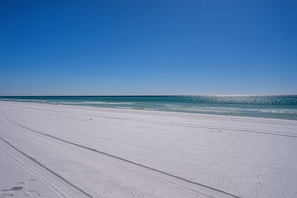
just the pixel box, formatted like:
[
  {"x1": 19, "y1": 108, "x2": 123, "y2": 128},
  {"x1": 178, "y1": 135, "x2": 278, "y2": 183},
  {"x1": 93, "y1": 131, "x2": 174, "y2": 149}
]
[{"x1": 0, "y1": 95, "x2": 297, "y2": 120}]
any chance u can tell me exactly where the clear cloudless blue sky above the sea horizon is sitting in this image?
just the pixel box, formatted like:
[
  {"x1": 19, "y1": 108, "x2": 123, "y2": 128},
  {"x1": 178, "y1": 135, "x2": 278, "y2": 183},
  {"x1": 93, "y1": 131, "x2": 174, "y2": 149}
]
[{"x1": 0, "y1": 0, "x2": 297, "y2": 95}]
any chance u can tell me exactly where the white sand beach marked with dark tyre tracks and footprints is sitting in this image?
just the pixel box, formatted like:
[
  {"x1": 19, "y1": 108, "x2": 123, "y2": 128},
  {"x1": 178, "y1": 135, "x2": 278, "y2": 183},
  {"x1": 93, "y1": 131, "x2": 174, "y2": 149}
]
[{"x1": 0, "y1": 101, "x2": 297, "y2": 198}]
